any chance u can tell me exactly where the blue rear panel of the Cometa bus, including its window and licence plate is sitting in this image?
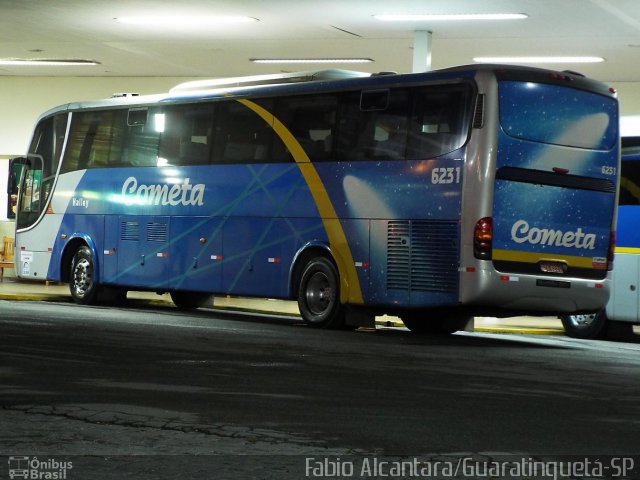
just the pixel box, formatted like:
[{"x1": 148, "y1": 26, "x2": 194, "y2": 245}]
[{"x1": 493, "y1": 78, "x2": 619, "y2": 282}]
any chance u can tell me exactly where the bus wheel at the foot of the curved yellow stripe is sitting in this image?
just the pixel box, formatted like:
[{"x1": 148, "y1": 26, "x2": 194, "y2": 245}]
[{"x1": 298, "y1": 257, "x2": 345, "y2": 329}]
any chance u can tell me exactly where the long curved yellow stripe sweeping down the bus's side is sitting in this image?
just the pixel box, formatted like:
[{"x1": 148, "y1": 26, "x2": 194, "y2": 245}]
[{"x1": 236, "y1": 99, "x2": 364, "y2": 304}]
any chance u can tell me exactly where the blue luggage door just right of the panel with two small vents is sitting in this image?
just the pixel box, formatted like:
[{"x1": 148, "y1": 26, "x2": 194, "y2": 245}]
[{"x1": 169, "y1": 217, "x2": 224, "y2": 292}]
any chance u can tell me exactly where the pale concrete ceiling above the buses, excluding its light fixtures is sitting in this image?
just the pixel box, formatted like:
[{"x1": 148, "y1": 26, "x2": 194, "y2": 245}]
[{"x1": 0, "y1": 0, "x2": 640, "y2": 82}]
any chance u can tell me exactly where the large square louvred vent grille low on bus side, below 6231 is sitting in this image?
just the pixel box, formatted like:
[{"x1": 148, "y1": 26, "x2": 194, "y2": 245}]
[{"x1": 387, "y1": 221, "x2": 459, "y2": 293}]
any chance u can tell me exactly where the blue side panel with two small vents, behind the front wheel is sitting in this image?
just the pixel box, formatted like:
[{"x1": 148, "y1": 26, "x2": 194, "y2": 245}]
[{"x1": 103, "y1": 215, "x2": 170, "y2": 290}]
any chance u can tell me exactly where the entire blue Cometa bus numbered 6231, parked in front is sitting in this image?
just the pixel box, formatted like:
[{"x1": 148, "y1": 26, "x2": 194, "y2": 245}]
[{"x1": 16, "y1": 65, "x2": 619, "y2": 332}]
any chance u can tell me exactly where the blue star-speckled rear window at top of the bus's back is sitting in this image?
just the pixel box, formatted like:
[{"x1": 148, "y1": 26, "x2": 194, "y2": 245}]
[{"x1": 499, "y1": 81, "x2": 617, "y2": 150}]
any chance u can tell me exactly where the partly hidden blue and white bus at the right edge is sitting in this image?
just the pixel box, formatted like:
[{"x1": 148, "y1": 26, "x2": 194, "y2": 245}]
[{"x1": 561, "y1": 136, "x2": 640, "y2": 339}]
